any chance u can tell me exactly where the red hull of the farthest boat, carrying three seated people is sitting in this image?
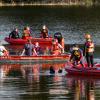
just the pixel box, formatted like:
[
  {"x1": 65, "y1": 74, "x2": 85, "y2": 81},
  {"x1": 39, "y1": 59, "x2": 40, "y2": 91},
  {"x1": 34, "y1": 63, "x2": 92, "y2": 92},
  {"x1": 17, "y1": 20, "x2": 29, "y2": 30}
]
[{"x1": 5, "y1": 37, "x2": 53, "y2": 46}]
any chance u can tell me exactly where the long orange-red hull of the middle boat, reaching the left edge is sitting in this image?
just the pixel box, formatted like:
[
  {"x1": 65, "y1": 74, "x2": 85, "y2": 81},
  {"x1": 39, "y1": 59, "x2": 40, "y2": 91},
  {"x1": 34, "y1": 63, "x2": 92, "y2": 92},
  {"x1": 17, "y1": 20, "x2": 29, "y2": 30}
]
[{"x1": 0, "y1": 54, "x2": 70, "y2": 63}]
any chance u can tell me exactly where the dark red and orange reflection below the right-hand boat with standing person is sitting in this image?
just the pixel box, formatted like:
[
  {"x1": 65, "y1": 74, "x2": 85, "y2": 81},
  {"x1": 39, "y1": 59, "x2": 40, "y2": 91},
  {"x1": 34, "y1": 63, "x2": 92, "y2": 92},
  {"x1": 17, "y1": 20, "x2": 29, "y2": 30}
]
[{"x1": 68, "y1": 76, "x2": 97, "y2": 100}]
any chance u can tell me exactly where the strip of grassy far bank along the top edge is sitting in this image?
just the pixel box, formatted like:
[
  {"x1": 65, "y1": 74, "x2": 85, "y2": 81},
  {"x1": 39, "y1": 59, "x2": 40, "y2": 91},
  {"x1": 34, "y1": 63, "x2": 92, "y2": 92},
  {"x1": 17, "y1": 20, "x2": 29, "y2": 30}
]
[{"x1": 0, "y1": 0, "x2": 100, "y2": 5}]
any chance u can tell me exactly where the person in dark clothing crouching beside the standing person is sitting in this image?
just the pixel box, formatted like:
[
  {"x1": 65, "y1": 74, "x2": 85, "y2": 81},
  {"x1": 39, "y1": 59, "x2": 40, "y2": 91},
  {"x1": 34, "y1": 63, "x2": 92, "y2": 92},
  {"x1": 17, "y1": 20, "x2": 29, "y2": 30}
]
[{"x1": 70, "y1": 44, "x2": 84, "y2": 67}]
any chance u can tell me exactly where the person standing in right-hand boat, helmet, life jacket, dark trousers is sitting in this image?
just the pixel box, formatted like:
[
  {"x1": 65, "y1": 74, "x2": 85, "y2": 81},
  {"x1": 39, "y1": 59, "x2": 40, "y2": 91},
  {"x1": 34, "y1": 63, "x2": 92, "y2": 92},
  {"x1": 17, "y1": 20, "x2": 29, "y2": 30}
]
[{"x1": 83, "y1": 36, "x2": 94, "y2": 67}]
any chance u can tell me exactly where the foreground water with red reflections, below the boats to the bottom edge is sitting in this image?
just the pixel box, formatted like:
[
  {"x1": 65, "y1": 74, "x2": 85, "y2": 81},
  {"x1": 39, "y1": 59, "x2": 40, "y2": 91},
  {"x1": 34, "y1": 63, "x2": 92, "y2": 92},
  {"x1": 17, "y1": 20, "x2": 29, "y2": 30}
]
[{"x1": 0, "y1": 63, "x2": 100, "y2": 100}]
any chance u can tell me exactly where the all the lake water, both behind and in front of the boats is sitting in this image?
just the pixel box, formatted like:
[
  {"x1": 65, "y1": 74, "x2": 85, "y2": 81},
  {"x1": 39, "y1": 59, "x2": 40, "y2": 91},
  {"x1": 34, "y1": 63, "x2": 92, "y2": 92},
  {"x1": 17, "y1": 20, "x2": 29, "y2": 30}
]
[{"x1": 0, "y1": 6, "x2": 100, "y2": 100}]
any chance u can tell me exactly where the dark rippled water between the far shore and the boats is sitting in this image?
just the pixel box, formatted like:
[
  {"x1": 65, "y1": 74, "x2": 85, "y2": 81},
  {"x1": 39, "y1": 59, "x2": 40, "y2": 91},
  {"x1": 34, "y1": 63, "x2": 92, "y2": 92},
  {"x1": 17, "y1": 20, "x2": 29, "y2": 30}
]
[{"x1": 0, "y1": 7, "x2": 100, "y2": 44}]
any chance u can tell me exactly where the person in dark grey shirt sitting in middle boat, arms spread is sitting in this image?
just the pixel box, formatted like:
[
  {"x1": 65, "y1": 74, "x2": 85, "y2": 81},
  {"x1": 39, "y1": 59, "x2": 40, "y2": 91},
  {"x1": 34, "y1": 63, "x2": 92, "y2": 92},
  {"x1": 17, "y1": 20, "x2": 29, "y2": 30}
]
[{"x1": 21, "y1": 39, "x2": 37, "y2": 56}]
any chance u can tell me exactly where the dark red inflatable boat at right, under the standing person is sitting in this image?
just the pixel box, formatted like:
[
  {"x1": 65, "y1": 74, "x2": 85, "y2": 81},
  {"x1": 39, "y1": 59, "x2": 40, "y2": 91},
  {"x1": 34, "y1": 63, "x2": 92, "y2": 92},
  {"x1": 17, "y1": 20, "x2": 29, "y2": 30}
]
[{"x1": 66, "y1": 63, "x2": 100, "y2": 76}]
